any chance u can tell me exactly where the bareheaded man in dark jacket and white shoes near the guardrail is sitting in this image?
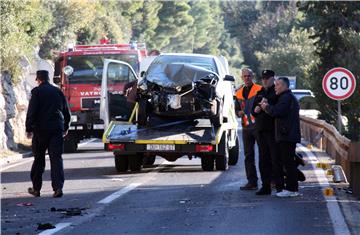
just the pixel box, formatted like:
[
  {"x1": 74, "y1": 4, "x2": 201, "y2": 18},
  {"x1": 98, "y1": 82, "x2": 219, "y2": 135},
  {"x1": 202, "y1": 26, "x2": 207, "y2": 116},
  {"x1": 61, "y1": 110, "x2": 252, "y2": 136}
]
[{"x1": 260, "y1": 77, "x2": 301, "y2": 197}]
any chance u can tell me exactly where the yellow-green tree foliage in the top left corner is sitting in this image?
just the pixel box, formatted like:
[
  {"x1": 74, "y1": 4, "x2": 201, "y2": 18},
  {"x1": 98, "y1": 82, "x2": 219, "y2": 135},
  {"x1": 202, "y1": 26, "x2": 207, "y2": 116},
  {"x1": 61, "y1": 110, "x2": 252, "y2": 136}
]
[{"x1": 0, "y1": 0, "x2": 52, "y2": 80}]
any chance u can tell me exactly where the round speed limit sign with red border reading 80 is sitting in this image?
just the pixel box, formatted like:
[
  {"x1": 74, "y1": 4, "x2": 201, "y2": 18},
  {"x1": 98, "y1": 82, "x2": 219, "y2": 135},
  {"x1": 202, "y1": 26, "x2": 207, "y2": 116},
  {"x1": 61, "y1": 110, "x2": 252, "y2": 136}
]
[{"x1": 322, "y1": 67, "x2": 356, "y2": 100}]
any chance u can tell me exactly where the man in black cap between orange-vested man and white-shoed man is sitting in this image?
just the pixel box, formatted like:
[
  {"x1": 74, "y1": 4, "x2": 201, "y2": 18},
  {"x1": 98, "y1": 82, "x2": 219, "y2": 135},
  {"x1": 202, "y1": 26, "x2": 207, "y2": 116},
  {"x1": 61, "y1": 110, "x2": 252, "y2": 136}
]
[{"x1": 252, "y1": 70, "x2": 283, "y2": 195}]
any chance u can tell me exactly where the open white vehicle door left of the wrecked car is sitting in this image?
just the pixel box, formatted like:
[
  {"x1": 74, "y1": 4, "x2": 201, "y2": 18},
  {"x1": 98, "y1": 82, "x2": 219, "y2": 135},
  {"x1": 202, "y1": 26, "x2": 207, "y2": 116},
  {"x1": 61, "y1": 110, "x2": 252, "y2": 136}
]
[{"x1": 100, "y1": 59, "x2": 138, "y2": 129}]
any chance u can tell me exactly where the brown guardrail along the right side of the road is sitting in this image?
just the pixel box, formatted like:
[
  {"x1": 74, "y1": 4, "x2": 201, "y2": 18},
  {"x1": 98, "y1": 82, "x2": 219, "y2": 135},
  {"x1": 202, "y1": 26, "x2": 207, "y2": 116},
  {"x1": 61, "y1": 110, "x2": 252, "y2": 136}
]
[{"x1": 300, "y1": 116, "x2": 360, "y2": 197}]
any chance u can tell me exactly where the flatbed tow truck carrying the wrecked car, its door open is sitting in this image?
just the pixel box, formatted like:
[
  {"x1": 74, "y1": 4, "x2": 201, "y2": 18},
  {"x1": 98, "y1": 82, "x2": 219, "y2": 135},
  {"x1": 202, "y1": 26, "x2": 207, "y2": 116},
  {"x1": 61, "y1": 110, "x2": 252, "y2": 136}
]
[{"x1": 100, "y1": 59, "x2": 239, "y2": 172}]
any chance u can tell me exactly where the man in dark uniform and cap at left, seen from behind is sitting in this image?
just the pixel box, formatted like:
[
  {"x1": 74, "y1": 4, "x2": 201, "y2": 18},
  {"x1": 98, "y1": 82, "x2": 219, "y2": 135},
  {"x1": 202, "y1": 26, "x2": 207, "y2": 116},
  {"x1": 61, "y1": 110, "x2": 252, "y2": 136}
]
[{"x1": 26, "y1": 70, "x2": 71, "y2": 197}]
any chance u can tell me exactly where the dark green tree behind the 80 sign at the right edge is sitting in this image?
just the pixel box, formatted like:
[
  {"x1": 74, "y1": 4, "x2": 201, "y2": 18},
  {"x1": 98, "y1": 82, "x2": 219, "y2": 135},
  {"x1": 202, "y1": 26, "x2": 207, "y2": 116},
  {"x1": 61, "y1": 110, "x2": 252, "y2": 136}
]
[{"x1": 299, "y1": 2, "x2": 360, "y2": 141}]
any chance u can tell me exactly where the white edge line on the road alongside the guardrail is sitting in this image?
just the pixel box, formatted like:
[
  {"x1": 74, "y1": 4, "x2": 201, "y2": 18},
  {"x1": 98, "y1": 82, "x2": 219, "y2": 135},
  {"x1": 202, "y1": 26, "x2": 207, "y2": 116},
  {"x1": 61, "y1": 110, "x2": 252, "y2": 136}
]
[{"x1": 297, "y1": 145, "x2": 351, "y2": 235}]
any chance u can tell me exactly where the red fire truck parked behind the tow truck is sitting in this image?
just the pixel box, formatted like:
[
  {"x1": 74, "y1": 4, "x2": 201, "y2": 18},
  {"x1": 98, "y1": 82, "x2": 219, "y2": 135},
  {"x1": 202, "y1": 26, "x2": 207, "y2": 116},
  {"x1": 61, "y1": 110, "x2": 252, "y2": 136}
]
[{"x1": 54, "y1": 43, "x2": 147, "y2": 152}]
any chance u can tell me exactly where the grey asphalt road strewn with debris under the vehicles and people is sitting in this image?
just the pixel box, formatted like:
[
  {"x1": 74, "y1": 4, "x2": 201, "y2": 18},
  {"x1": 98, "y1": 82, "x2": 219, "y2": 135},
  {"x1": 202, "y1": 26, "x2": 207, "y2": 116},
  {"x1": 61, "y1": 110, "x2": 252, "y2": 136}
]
[{"x1": 1, "y1": 134, "x2": 348, "y2": 235}]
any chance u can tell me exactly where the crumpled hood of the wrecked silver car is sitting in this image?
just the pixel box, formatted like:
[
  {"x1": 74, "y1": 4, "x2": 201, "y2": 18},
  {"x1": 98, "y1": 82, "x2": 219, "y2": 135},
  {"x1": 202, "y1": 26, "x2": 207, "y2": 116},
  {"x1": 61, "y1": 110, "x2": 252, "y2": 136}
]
[{"x1": 146, "y1": 63, "x2": 215, "y2": 88}]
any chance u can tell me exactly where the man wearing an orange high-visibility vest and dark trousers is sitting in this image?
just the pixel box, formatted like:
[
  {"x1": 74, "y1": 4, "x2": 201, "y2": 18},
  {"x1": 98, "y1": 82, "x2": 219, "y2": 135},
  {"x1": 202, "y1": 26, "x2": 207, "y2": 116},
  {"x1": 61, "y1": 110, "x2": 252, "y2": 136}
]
[{"x1": 236, "y1": 68, "x2": 262, "y2": 190}]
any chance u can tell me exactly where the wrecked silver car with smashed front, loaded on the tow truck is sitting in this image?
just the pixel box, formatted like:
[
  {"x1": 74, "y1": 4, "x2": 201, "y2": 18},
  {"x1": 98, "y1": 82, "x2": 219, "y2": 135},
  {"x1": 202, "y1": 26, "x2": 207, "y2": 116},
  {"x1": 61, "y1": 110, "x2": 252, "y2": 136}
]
[{"x1": 138, "y1": 54, "x2": 234, "y2": 126}]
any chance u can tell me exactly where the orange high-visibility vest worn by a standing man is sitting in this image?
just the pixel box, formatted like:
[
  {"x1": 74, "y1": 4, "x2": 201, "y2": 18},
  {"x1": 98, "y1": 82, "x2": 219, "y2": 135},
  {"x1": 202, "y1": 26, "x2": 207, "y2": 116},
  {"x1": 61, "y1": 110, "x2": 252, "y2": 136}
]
[{"x1": 236, "y1": 83, "x2": 262, "y2": 127}]
